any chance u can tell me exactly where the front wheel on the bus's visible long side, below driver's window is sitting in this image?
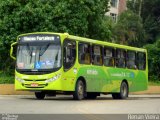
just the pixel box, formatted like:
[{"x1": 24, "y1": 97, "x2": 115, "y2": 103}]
[{"x1": 73, "y1": 80, "x2": 85, "y2": 100}]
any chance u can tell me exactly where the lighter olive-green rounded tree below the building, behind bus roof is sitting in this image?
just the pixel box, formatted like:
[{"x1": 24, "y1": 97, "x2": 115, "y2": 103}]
[{"x1": 114, "y1": 10, "x2": 145, "y2": 47}]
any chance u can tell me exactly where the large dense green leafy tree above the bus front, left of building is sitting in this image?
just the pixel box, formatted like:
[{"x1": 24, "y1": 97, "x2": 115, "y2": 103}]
[{"x1": 0, "y1": 0, "x2": 108, "y2": 69}]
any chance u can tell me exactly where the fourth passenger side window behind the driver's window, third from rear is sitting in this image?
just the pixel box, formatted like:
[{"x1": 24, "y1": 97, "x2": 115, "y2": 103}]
[{"x1": 116, "y1": 49, "x2": 126, "y2": 68}]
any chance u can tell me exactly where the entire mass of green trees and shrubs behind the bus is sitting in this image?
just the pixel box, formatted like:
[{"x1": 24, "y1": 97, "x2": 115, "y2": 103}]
[{"x1": 0, "y1": 0, "x2": 160, "y2": 83}]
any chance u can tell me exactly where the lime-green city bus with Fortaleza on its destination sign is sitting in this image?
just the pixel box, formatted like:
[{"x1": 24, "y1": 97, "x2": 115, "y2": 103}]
[{"x1": 10, "y1": 32, "x2": 148, "y2": 100}]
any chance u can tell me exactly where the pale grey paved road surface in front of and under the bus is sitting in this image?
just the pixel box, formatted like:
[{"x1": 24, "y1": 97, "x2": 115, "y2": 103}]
[{"x1": 0, "y1": 95, "x2": 160, "y2": 114}]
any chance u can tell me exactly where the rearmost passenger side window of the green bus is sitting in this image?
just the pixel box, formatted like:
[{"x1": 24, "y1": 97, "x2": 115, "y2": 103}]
[{"x1": 137, "y1": 52, "x2": 146, "y2": 70}]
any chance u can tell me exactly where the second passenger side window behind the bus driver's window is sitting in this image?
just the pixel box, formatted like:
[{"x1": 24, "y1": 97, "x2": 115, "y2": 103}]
[{"x1": 92, "y1": 45, "x2": 103, "y2": 65}]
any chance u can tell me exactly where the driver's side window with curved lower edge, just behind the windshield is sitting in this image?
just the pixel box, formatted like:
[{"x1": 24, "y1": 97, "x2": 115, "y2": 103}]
[{"x1": 63, "y1": 40, "x2": 76, "y2": 70}]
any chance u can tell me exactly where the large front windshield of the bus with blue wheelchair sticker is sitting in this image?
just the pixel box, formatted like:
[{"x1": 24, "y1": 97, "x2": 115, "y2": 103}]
[{"x1": 16, "y1": 43, "x2": 61, "y2": 71}]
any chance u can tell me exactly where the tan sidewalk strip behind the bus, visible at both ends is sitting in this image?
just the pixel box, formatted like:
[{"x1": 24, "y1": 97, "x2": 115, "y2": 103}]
[{"x1": 0, "y1": 84, "x2": 160, "y2": 95}]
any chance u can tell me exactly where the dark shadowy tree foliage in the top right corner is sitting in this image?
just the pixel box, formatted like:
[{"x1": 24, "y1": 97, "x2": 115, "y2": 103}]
[{"x1": 142, "y1": 0, "x2": 160, "y2": 43}]
